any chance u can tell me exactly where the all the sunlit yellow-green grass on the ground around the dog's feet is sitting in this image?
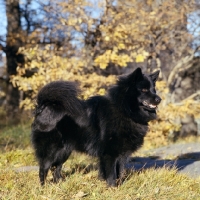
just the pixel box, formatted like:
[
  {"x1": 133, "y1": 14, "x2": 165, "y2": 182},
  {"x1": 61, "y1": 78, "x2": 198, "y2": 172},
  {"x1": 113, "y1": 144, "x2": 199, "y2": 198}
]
[{"x1": 0, "y1": 124, "x2": 200, "y2": 200}]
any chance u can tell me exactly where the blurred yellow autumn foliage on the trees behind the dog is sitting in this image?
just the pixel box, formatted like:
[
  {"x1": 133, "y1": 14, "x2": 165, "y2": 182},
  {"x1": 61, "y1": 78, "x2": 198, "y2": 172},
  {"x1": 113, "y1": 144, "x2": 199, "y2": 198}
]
[{"x1": 11, "y1": 0, "x2": 200, "y2": 141}]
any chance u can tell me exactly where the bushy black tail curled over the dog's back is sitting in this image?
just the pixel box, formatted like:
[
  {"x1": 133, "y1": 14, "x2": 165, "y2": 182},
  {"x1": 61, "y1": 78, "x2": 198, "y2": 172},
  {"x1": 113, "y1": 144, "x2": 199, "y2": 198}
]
[{"x1": 32, "y1": 81, "x2": 86, "y2": 132}]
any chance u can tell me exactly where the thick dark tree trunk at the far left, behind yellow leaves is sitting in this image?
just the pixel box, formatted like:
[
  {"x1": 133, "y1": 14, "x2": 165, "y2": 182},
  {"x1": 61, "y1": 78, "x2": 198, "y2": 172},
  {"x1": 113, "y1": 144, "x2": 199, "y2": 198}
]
[{"x1": 5, "y1": 0, "x2": 23, "y2": 122}]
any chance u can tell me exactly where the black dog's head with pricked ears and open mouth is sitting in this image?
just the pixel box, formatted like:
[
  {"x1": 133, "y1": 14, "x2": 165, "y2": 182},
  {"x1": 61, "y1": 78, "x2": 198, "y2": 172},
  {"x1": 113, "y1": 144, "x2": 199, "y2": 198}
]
[{"x1": 116, "y1": 68, "x2": 161, "y2": 122}]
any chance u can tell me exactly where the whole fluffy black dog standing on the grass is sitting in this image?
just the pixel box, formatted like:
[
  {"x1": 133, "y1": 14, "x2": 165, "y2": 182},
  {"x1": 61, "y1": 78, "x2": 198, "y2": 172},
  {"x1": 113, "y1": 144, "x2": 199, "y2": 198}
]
[{"x1": 32, "y1": 68, "x2": 161, "y2": 186}]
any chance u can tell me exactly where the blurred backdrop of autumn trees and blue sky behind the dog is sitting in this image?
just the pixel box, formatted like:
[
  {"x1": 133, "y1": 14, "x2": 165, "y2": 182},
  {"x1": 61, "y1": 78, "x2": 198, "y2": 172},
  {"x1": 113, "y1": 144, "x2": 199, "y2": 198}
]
[{"x1": 0, "y1": 0, "x2": 200, "y2": 144}]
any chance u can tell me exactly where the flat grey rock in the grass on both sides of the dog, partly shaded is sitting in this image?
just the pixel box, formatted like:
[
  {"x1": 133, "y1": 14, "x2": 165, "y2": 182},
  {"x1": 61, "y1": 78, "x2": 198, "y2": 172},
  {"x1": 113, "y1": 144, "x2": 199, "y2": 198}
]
[{"x1": 15, "y1": 142, "x2": 200, "y2": 177}]
